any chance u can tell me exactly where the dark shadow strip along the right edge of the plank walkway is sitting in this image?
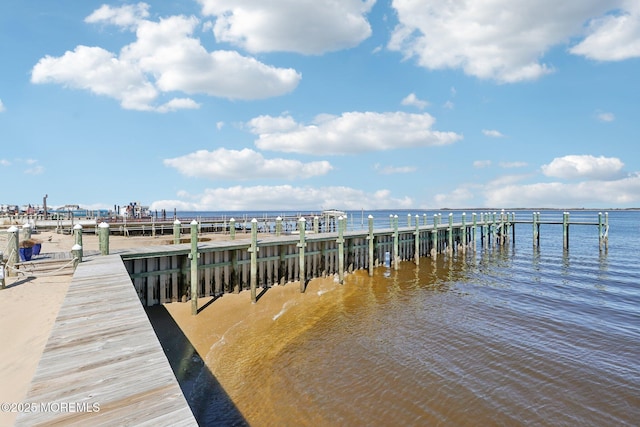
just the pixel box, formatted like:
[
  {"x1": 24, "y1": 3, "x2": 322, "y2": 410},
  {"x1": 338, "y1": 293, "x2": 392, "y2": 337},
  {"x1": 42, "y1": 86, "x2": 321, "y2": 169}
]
[{"x1": 146, "y1": 305, "x2": 249, "y2": 426}]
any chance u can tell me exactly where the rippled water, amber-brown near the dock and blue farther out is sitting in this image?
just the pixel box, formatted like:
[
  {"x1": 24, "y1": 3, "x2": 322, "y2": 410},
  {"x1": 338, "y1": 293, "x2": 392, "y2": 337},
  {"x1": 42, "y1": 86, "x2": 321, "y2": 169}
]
[{"x1": 146, "y1": 211, "x2": 640, "y2": 427}]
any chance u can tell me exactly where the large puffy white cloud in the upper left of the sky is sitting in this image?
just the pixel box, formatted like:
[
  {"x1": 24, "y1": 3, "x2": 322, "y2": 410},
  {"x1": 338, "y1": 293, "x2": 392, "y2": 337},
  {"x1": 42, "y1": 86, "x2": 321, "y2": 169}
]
[{"x1": 31, "y1": 5, "x2": 301, "y2": 112}]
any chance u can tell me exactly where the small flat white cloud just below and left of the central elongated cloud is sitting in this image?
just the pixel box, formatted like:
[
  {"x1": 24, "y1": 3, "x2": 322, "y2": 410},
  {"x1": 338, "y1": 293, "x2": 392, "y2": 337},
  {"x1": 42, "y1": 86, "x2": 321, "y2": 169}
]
[{"x1": 164, "y1": 148, "x2": 333, "y2": 180}]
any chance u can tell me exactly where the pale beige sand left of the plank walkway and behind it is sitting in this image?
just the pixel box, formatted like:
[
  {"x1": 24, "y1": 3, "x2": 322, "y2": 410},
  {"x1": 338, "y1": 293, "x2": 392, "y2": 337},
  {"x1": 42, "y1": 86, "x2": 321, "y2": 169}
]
[{"x1": 0, "y1": 232, "x2": 225, "y2": 427}]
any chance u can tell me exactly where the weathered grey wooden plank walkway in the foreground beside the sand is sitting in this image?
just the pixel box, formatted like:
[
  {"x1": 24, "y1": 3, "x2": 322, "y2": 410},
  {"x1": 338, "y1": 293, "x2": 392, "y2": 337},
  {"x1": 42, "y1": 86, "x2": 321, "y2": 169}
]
[{"x1": 16, "y1": 255, "x2": 197, "y2": 427}]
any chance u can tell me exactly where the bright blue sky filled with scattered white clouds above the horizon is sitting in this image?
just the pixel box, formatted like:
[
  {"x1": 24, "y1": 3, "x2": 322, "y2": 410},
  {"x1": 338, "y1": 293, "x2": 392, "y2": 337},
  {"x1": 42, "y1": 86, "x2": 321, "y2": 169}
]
[{"x1": 0, "y1": 0, "x2": 640, "y2": 210}]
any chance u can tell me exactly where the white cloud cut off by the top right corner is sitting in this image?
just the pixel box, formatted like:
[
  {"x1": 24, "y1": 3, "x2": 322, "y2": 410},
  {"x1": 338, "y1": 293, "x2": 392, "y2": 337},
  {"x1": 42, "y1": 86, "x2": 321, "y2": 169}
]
[{"x1": 569, "y1": 1, "x2": 640, "y2": 61}]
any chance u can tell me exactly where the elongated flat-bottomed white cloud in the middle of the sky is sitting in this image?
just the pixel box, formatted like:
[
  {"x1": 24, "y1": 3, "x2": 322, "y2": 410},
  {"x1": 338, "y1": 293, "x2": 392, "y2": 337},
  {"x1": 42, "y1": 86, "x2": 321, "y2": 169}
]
[{"x1": 248, "y1": 112, "x2": 462, "y2": 154}]
